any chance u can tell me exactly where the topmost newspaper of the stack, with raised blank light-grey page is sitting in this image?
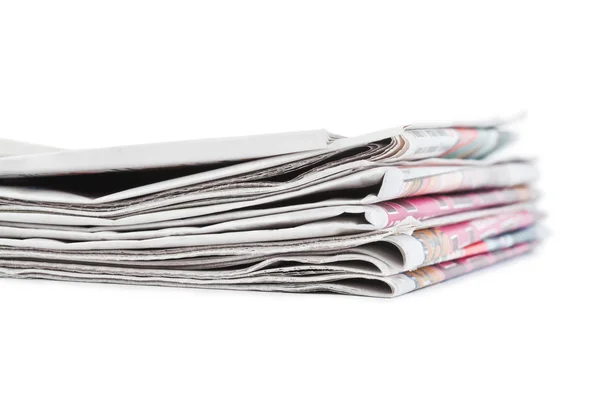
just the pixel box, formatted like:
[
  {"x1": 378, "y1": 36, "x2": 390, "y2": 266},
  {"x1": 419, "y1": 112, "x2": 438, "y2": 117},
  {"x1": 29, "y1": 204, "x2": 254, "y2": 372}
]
[{"x1": 0, "y1": 121, "x2": 512, "y2": 177}]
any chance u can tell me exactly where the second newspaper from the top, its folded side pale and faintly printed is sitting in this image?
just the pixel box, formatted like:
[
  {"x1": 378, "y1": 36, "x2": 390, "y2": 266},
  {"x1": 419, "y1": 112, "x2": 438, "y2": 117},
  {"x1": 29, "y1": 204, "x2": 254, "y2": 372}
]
[{"x1": 0, "y1": 162, "x2": 538, "y2": 226}]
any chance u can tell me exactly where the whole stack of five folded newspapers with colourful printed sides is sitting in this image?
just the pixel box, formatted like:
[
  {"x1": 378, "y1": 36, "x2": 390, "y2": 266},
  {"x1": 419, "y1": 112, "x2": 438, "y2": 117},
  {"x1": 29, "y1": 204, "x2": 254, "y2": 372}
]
[{"x1": 0, "y1": 116, "x2": 541, "y2": 297}]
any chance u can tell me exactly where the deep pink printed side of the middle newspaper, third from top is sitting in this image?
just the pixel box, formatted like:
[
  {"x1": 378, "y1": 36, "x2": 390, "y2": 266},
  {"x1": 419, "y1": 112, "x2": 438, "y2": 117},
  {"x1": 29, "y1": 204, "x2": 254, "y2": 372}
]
[{"x1": 376, "y1": 187, "x2": 533, "y2": 227}]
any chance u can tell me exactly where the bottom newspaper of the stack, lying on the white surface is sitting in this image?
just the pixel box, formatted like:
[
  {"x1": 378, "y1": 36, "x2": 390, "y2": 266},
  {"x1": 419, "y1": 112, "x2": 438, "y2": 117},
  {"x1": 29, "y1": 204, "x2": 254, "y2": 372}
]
[{"x1": 0, "y1": 231, "x2": 535, "y2": 297}]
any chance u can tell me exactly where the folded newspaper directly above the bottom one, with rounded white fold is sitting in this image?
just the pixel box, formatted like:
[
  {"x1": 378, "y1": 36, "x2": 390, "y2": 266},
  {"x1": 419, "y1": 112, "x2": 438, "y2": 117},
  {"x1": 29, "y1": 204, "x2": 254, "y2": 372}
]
[{"x1": 0, "y1": 205, "x2": 541, "y2": 269}]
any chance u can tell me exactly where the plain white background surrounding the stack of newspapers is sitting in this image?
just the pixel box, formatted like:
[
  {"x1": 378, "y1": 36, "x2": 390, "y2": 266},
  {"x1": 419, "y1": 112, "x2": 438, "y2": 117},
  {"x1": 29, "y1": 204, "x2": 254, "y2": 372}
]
[{"x1": 0, "y1": 0, "x2": 600, "y2": 399}]
